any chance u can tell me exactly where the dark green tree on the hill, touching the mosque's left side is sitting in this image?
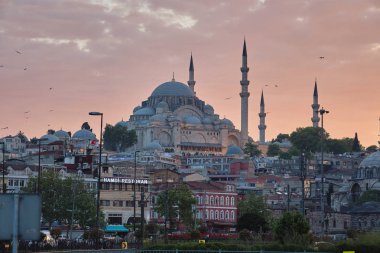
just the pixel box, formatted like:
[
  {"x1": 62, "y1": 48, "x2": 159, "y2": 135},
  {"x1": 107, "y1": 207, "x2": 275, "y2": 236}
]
[{"x1": 103, "y1": 124, "x2": 137, "y2": 151}]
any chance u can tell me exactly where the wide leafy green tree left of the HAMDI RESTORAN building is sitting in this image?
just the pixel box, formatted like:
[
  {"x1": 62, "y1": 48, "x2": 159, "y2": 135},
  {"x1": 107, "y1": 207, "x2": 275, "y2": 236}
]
[{"x1": 23, "y1": 171, "x2": 103, "y2": 227}]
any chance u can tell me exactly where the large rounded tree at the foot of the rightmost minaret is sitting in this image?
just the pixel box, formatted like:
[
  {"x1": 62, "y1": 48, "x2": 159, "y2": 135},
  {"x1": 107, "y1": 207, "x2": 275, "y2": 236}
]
[{"x1": 290, "y1": 127, "x2": 329, "y2": 155}]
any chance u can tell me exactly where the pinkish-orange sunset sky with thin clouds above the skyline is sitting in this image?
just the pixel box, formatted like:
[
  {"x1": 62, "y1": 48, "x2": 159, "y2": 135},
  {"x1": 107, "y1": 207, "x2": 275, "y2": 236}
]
[{"x1": 0, "y1": 0, "x2": 380, "y2": 146}]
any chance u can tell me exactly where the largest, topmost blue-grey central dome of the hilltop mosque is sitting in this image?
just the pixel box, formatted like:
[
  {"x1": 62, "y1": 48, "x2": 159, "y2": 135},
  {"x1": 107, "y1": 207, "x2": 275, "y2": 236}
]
[{"x1": 151, "y1": 81, "x2": 194, "y2": 97}]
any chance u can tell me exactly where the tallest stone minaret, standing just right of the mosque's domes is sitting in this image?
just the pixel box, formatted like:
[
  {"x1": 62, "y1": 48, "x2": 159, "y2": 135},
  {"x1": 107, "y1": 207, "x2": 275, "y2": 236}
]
[{"x1": 240, "y1": 39, "x2": 249, "y2": 146}]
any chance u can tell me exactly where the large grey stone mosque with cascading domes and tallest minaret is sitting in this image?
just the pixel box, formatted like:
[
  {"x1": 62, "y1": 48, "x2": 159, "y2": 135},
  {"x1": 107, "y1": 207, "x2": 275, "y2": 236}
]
[{"x1": 117, "y1": 41, "x2": 254, "y2": 154}]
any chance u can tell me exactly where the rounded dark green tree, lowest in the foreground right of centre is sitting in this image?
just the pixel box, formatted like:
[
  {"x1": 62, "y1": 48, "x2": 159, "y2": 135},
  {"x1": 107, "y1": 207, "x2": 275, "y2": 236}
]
[{"x1": 273, "y1": 212, "x2": 310, "y2": 243}]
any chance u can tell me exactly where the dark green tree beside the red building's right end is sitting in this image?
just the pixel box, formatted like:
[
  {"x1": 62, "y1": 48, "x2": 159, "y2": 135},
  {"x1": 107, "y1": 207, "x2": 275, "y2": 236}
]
[{"x1": 236, "y1": 194, "x2": 270, "y2": 233}]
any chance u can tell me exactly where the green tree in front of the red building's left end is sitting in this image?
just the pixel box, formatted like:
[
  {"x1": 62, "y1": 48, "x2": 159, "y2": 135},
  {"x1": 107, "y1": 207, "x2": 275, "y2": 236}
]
[{"x1": 155, "y1": 185, "x2": 196, "y2": 228}]
